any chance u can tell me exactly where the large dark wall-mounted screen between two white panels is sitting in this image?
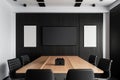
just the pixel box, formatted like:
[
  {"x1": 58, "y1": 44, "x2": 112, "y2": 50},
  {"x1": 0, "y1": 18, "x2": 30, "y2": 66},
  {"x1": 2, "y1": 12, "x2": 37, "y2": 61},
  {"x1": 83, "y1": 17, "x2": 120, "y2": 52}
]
[{"x1": 43, "y1": 27, "x2": 77, "y2": 45}]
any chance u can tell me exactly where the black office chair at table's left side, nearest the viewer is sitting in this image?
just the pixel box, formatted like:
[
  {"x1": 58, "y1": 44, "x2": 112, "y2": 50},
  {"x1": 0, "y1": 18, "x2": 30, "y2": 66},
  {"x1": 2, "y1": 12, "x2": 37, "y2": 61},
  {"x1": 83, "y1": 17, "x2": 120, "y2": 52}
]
[{"x1": 8, "y1": 58, "x2": 23, "y2": 80}]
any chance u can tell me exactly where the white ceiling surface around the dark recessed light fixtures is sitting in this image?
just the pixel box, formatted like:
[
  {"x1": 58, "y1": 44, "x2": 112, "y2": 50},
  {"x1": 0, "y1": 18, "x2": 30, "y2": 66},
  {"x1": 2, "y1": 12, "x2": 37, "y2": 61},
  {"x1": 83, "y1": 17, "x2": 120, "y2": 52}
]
[{"x1": 7, "y1": 0, "x2": 117, "y2": 7}]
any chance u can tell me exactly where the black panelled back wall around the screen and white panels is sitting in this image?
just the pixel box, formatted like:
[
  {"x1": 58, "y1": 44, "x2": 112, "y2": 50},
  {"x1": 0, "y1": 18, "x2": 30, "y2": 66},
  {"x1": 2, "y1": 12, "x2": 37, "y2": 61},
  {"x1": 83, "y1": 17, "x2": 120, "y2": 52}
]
[{"x1": 16, "y1": 13, "x2": 103, "y2": 60}]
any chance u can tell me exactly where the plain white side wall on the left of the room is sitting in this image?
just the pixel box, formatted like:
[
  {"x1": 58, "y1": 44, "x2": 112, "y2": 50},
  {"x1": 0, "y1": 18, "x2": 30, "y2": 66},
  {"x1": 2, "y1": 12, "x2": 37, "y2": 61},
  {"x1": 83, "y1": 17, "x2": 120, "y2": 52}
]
[{"x1": 0, "y1": 0, "x2": 15, "y2": 80}]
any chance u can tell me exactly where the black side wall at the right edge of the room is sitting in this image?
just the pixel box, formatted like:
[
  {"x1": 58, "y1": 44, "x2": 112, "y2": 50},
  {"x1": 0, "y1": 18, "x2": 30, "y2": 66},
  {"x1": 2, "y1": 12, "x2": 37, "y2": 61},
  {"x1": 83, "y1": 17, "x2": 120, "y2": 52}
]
[{"x1": 110, "y1": 5, "x2": 120, "y2": 79}]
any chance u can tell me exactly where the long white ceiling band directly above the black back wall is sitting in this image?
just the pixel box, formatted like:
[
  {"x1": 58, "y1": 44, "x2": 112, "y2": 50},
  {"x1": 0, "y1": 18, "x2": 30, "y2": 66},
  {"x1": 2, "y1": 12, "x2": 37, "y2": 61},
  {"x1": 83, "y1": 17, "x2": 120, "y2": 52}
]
[{"x1": 15, "y1": 7, "x2": 109, "y2": 13}]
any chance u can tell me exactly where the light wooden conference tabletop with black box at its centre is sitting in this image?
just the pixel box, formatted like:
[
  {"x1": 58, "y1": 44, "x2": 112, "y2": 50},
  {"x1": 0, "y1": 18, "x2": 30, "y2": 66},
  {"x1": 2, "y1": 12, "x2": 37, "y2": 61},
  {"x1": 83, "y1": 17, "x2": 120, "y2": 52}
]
[{"x1": 16, "y1": 56, "x2": 103, "y2": 73}]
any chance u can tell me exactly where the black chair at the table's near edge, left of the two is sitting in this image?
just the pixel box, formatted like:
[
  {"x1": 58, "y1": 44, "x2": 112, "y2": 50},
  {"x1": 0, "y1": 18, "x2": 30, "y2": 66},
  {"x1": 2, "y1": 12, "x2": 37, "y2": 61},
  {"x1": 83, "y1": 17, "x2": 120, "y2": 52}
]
[{"x1": 25, "y1": 69, "x2": 54, "y2": 80}]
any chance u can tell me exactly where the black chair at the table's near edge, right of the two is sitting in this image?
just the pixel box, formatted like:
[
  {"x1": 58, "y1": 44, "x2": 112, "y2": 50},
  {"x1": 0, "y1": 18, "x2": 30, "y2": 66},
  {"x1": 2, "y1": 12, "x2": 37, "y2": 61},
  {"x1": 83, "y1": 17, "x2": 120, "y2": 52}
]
[{"x1": 66, "y1": 69, "x2": 94, "y2": 80}]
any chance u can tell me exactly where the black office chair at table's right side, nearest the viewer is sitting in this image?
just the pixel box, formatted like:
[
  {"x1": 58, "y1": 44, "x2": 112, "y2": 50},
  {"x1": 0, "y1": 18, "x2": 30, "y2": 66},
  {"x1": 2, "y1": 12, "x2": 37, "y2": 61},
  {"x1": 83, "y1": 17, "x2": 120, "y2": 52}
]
[{"x1": 95, "y1": 58, "x2": 113, "y2": 79}]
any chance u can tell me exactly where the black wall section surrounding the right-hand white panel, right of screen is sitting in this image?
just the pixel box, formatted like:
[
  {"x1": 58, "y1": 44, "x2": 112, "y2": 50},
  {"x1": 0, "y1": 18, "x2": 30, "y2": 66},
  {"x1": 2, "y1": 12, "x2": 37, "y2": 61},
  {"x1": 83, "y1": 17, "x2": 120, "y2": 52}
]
[{"x1": 80, "y1": 14, "x2": 103, "y2": 59}]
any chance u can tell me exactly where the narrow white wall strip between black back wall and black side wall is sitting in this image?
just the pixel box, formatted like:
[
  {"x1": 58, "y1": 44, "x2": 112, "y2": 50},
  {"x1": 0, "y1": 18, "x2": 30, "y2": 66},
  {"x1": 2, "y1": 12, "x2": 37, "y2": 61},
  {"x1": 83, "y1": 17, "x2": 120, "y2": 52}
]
[{"x1": 103, "y1": 12, "x2": 110, "y2": 59}]
